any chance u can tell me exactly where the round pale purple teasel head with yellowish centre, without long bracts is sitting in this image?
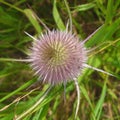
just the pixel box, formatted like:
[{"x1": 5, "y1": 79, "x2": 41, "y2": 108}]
[{"x1": 30, "y1": 30, "x2": 86, "y2": 84}]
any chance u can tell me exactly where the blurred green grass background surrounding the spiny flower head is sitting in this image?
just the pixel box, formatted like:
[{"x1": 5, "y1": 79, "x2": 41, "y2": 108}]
[{"x1": 0, "y1": 0, "x2": 120, "y2": 120}]
